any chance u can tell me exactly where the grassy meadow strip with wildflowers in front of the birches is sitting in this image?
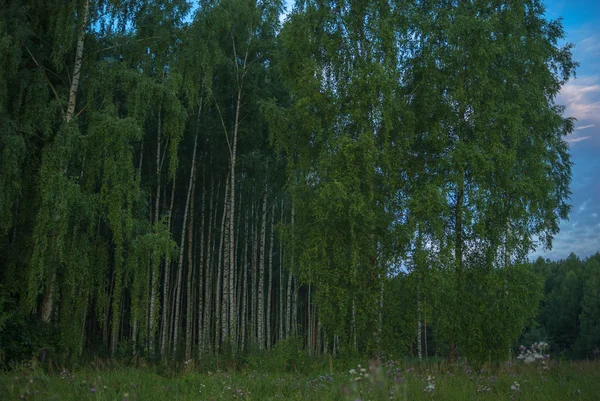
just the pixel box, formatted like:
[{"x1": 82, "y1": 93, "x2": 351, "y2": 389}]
[{"x1": 0, "y1": 358, "x2": 600, "y2": 401}]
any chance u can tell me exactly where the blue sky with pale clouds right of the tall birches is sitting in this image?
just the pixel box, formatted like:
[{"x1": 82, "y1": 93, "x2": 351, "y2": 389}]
[{"x1": 531, "y1": 0, "x2": 600, "y2": 259}]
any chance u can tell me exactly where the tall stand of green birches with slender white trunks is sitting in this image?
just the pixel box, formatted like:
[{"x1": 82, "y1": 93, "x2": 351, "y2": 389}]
[{"x1": 0, "y1": 0, "x2": 576, "y2": 360}]
